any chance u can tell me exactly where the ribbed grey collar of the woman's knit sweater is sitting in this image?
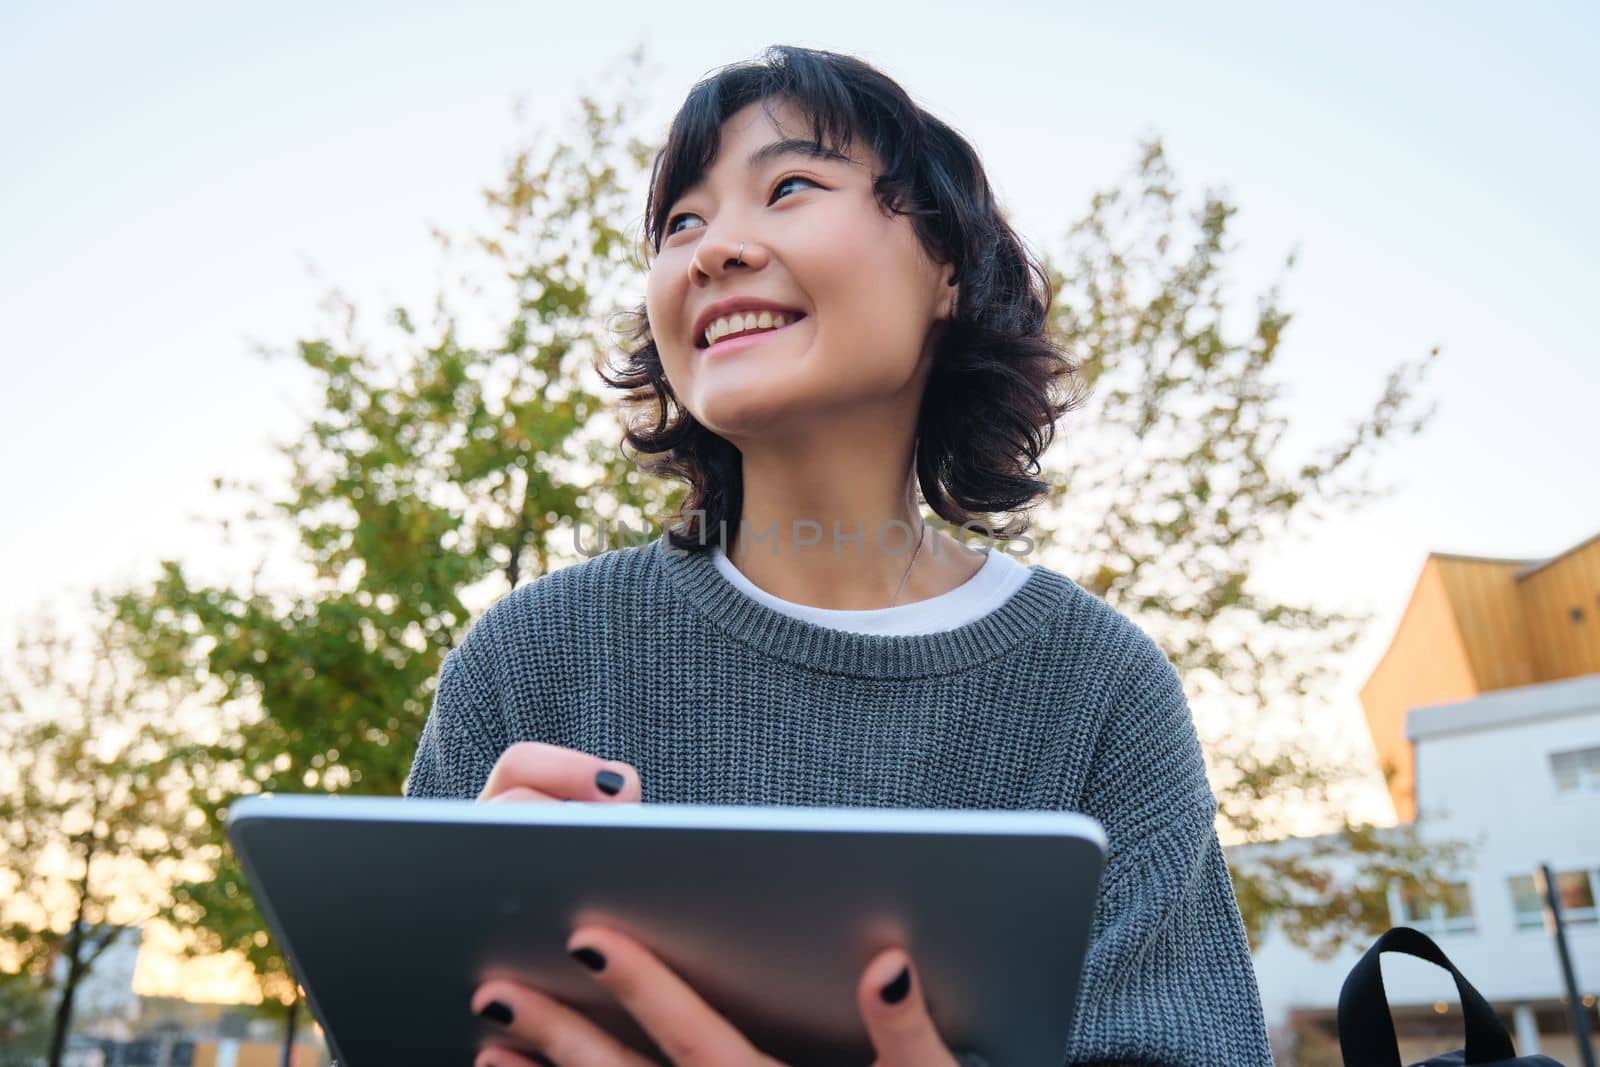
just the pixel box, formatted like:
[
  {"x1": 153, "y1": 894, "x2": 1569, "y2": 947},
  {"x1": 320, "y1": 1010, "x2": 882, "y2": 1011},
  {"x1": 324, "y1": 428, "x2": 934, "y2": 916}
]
[{"x1": 648, "y1": 533, "x2": 1075, "y2": 678}]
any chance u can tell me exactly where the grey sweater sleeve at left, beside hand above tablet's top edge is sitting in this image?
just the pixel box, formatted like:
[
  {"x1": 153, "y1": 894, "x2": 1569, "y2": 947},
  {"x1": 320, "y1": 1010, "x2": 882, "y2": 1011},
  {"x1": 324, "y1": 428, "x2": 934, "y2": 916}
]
[{"x1": 403, "y1": 645, "x2": 499, "y2": 800}]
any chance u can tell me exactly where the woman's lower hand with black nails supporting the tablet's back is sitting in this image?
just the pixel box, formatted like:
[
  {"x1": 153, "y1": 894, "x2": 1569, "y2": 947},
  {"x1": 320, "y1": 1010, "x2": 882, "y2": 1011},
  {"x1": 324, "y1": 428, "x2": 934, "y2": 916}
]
[{"x1": 472, "y1": 926, "x2": 957, "y2": 1067}]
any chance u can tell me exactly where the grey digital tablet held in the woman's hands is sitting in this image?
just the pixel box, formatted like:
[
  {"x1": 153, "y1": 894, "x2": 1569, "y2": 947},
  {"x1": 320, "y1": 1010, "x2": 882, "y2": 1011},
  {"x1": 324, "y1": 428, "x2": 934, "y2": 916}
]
[{"x1": 227, "y1": 795, "x2": 1106, "y2": 1067}]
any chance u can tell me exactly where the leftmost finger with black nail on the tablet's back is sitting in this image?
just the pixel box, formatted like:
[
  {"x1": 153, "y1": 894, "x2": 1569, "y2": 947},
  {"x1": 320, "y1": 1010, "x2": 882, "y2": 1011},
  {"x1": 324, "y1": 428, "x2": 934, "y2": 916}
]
[{"x1": 472, "y1": 979, "x2": 651, "y2": 1067}]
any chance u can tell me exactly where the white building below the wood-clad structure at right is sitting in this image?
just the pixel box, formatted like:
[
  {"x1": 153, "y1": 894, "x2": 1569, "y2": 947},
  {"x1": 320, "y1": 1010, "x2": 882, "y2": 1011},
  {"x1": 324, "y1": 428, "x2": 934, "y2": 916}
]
[{"x1": 1237, "y1": 673, "x2": 1600, "y2": 1064}]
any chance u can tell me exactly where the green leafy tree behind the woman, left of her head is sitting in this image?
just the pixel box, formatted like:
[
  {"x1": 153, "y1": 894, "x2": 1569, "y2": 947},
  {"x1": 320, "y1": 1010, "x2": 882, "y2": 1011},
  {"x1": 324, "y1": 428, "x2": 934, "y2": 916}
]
[{"x1": 109, "y1": 53, "x2": 662, "y2": 1040}]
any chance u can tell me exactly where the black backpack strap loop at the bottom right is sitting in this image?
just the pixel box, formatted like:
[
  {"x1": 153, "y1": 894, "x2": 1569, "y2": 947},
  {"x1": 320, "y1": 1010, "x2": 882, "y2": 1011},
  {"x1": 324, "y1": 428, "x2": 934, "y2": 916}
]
[{"x1": 1339, "y1": 926, "x2": 1517, "y2": 1067}]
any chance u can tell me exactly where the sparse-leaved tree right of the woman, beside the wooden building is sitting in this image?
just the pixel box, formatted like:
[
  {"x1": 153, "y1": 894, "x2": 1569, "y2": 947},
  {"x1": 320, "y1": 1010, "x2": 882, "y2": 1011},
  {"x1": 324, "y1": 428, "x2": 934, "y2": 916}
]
[{"x1": 1035, "y1": 141, "x2": 1461, "y2": 953}]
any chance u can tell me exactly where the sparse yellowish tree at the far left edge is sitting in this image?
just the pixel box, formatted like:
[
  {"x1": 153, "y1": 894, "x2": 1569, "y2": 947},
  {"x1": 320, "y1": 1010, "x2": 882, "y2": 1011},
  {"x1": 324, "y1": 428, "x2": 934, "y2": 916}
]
[{"x1": 0, "y1": 607, "x2": 195, "y2": 1067}]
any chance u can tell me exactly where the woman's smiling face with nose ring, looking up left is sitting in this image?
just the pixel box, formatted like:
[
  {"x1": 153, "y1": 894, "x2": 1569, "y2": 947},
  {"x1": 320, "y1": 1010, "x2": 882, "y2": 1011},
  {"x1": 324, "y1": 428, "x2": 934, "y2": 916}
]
[{"x1": 645, "y1": 99, "x2": 955, "y2": 443}]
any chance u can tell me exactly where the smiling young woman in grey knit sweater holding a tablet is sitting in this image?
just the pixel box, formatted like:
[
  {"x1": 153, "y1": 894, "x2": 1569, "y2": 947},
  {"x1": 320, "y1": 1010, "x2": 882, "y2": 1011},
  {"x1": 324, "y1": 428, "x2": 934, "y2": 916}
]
[{"x1": 406, "y1": 48, "x2": 1272, "y2": 1067}]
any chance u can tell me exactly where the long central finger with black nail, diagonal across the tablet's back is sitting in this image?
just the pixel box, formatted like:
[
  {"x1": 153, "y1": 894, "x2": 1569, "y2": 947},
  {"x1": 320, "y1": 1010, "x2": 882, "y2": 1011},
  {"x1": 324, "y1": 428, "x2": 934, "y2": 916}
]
[{"x1": 569, "y1": 926, "x2": 778, "y2": 1067}]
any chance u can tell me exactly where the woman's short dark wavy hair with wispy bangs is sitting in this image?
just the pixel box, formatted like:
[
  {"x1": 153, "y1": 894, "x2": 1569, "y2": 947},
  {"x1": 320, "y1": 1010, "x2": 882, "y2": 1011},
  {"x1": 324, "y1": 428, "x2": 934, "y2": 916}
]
[{"x1": 598, "y1": 45, "x2": 1083, "y2": 552}]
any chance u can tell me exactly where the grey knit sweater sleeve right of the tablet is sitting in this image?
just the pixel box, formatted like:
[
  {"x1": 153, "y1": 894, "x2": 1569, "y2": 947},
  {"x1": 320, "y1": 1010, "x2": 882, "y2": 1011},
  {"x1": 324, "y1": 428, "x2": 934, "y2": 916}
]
[{"x1": 1067, "y1": 632, "x2": 1272, "y2": 1067}]
